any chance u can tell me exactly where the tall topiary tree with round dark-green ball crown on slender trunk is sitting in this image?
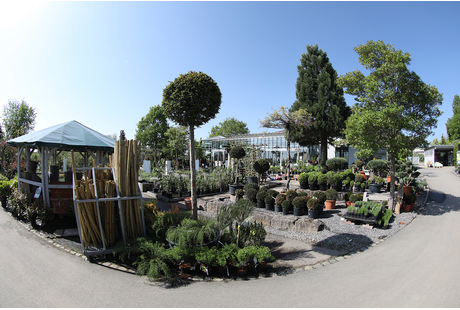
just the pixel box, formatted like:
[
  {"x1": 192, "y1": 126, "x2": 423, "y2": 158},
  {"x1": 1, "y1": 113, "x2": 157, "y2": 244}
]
[{"x1": 162, "y1": 71, "x2": 222, "y2": 220}]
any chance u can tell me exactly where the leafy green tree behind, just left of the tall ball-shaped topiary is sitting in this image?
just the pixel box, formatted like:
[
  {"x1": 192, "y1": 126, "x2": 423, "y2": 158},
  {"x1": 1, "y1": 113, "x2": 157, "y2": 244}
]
[{"x1": 135, "y1": 105, "x2": 169, "y2": 163}]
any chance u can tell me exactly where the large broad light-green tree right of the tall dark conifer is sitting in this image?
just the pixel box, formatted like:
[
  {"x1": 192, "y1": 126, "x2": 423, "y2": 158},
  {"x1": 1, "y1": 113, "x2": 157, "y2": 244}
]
[{"x1": 338, "y1": 41, "x2": 442, "y2": 208}]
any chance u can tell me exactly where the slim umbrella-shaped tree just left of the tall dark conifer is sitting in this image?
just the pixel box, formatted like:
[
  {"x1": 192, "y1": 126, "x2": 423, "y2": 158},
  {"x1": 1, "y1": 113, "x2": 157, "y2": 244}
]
[{"x1": 260, "y1": 107, "x2": 311, "y2": 190}]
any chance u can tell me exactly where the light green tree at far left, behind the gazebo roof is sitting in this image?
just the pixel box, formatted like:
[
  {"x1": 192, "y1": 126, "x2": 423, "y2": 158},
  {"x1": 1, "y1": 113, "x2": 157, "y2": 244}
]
[{"x1": 3, "y1": 99, "x2": 37, "y2": 140}]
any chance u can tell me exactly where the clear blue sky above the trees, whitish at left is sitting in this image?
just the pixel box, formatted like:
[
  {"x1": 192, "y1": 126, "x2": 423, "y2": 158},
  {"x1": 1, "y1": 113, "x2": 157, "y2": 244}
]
[{"x1": 0, "y1": 1, "x2": 460, "y2": 141}]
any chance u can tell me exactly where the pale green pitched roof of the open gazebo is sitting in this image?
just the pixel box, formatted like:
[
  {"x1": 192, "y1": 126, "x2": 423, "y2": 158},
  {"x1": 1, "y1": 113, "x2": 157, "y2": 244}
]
[{"x1": 6, "y1": 121, "x2": 115, "y2": 152}]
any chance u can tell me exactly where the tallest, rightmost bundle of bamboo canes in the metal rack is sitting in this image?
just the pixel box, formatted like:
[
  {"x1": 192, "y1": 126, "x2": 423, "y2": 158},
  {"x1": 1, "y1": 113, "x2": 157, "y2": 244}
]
[{"x1": 110, "y1": 140, "x2": 143, "y2": 242}]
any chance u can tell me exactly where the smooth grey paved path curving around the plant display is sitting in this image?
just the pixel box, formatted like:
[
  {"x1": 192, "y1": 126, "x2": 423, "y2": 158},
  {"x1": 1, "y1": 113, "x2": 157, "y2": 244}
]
[{"x1": 0, "y1": 167, "x2": 460, "y2": 307}]
